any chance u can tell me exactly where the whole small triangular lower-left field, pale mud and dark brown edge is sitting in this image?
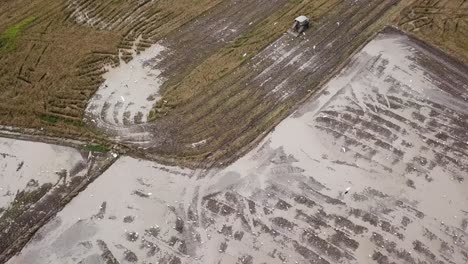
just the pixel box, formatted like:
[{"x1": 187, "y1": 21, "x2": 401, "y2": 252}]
[{"x1": 0, "y1": 138, "x2": 113, "y2": 263}]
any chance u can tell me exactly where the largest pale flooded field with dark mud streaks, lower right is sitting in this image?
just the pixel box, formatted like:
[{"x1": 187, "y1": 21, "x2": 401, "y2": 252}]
[{"x1": 8, "y1": 28, "x2": 468, "y2": 264}]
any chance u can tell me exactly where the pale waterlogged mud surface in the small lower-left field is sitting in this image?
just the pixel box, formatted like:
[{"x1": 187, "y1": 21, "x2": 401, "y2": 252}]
[{"x1": 0, "y1": 138, "x2": 88, "y2": 211}]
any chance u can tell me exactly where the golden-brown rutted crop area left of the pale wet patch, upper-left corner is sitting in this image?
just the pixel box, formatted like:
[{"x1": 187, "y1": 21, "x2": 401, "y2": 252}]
[{"x1": 0, "y1": 0, "x2": 230, "y2": 142}]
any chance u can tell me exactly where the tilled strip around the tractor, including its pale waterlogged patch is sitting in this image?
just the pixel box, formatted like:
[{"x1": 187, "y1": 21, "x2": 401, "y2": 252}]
[{"x1": 87, "y1": 0, "x2": 408, "y2": 163}]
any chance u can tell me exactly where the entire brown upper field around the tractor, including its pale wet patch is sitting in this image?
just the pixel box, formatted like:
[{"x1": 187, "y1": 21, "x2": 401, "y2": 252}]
[{"x1": 0, "y1": 0, "x2": 467, "y2": 167}]
